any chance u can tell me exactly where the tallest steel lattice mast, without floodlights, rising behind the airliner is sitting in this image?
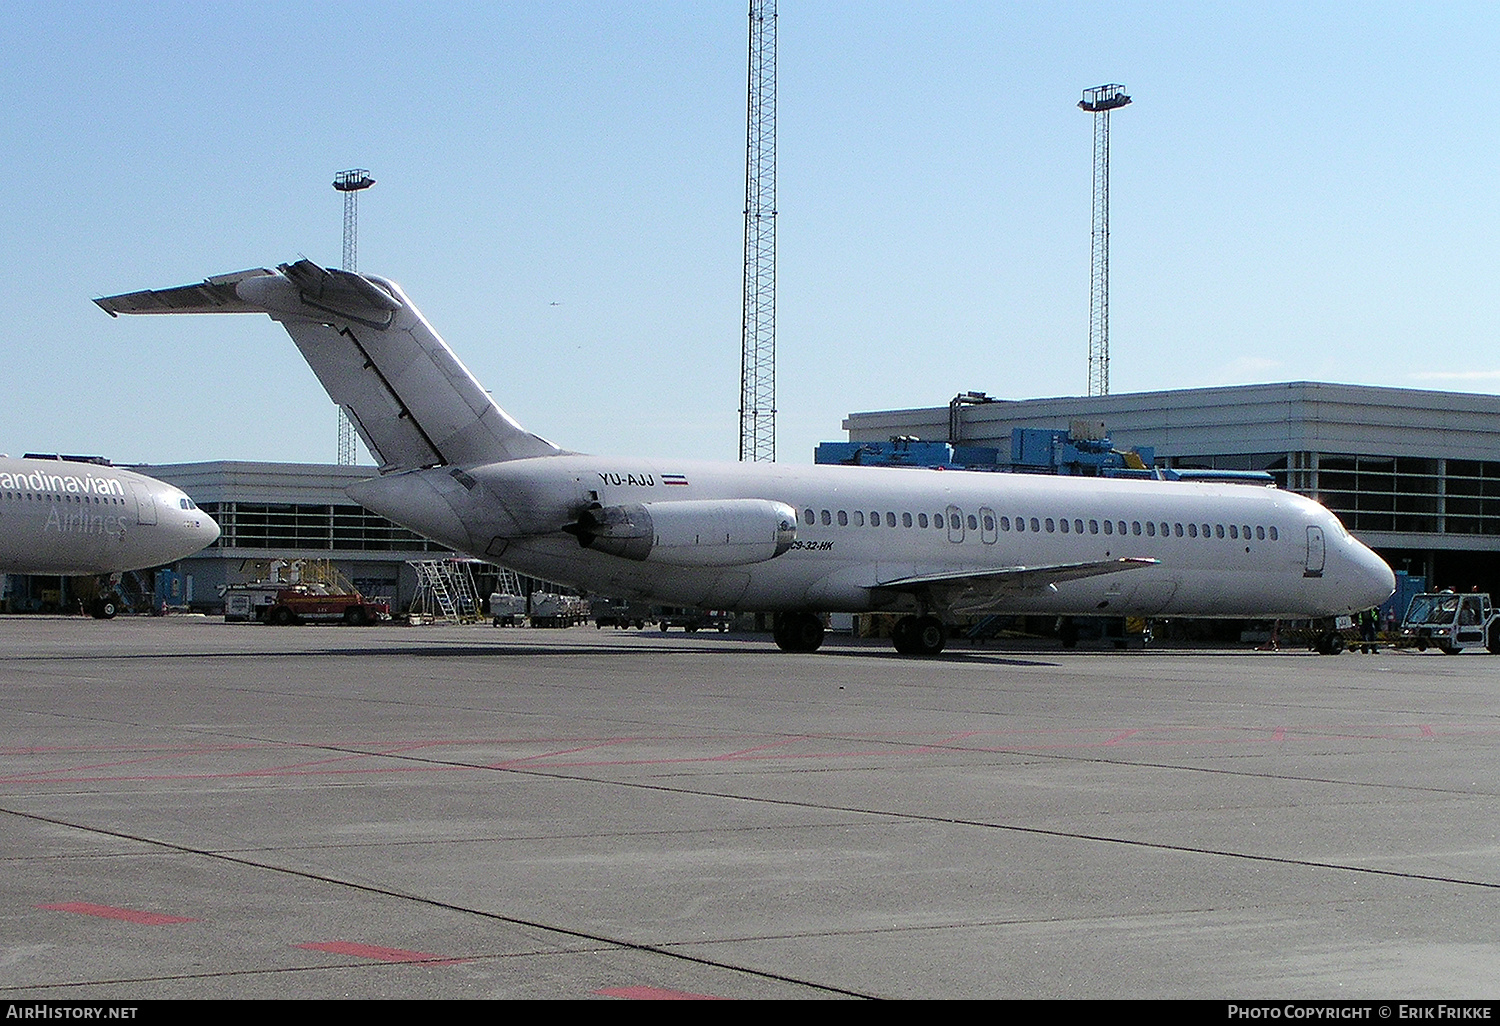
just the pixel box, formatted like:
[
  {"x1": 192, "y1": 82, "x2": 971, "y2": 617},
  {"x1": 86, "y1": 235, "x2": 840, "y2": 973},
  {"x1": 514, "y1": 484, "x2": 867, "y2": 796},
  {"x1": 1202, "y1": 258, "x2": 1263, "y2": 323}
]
[{"x1": 740, "y1": 0, "x2": 776, "y2": 461}]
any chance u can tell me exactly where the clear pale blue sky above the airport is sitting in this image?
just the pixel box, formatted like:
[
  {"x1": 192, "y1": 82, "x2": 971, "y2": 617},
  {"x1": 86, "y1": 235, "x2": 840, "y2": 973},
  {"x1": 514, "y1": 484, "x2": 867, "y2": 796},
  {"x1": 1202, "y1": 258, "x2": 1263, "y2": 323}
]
[{"x1": 0, "y1": 0, "x2": 1500, "y2": 464}]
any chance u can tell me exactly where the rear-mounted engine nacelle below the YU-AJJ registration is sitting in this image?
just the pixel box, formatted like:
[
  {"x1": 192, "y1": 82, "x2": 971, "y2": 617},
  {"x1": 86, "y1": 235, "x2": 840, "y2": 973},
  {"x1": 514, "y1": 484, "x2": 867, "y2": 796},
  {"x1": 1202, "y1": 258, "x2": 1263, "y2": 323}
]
[{"x1": 566, "y1": 500, "x2": 797, "y2": 567}]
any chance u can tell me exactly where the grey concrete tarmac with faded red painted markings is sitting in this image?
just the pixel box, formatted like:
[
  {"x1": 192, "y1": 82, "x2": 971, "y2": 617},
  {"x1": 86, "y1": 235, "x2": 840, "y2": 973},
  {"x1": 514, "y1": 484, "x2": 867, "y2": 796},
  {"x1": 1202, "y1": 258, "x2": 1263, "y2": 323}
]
[{"x1": 0, "y1": 617, "x2": 1500, "y2": 1001}]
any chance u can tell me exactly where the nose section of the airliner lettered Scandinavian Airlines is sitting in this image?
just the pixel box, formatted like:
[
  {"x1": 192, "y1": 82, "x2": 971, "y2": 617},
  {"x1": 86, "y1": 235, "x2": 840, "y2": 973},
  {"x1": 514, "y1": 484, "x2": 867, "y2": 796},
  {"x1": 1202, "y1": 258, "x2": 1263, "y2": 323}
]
[{"x1": 0, "y1": 456, "x2": 219, "y2": 576}]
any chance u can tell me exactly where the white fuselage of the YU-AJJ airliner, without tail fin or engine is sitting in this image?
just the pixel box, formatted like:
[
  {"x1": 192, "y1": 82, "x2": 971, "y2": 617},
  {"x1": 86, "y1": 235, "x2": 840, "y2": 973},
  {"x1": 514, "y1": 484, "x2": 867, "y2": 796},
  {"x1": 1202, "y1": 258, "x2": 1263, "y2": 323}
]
[{"x1": 351, "y1": 456, "x2": 1392, "y2": 617}]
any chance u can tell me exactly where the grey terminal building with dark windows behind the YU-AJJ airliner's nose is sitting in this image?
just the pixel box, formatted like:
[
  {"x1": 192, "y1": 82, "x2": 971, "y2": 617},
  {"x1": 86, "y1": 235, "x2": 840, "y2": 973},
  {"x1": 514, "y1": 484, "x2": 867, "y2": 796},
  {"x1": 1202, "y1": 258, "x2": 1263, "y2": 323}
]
[{"x1": 843, "y1": 381, "x2": 1500, "y2": 594}]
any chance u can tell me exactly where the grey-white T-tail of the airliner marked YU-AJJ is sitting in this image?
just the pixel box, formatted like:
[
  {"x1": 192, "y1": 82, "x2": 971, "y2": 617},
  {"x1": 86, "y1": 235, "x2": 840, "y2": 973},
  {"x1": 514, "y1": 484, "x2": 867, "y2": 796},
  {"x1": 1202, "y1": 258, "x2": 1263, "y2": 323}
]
[{"x1": 95, "y1": 260, "x2": 563, "y2": 474}]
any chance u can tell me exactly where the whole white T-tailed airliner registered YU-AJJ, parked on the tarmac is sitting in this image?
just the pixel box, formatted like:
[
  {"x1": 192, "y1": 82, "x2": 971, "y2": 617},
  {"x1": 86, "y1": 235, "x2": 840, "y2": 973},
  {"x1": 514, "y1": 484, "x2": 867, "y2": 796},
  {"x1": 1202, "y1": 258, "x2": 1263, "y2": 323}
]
[{"x1": 96, "y1": 260, "x2": 1395, "y2": 654}]
